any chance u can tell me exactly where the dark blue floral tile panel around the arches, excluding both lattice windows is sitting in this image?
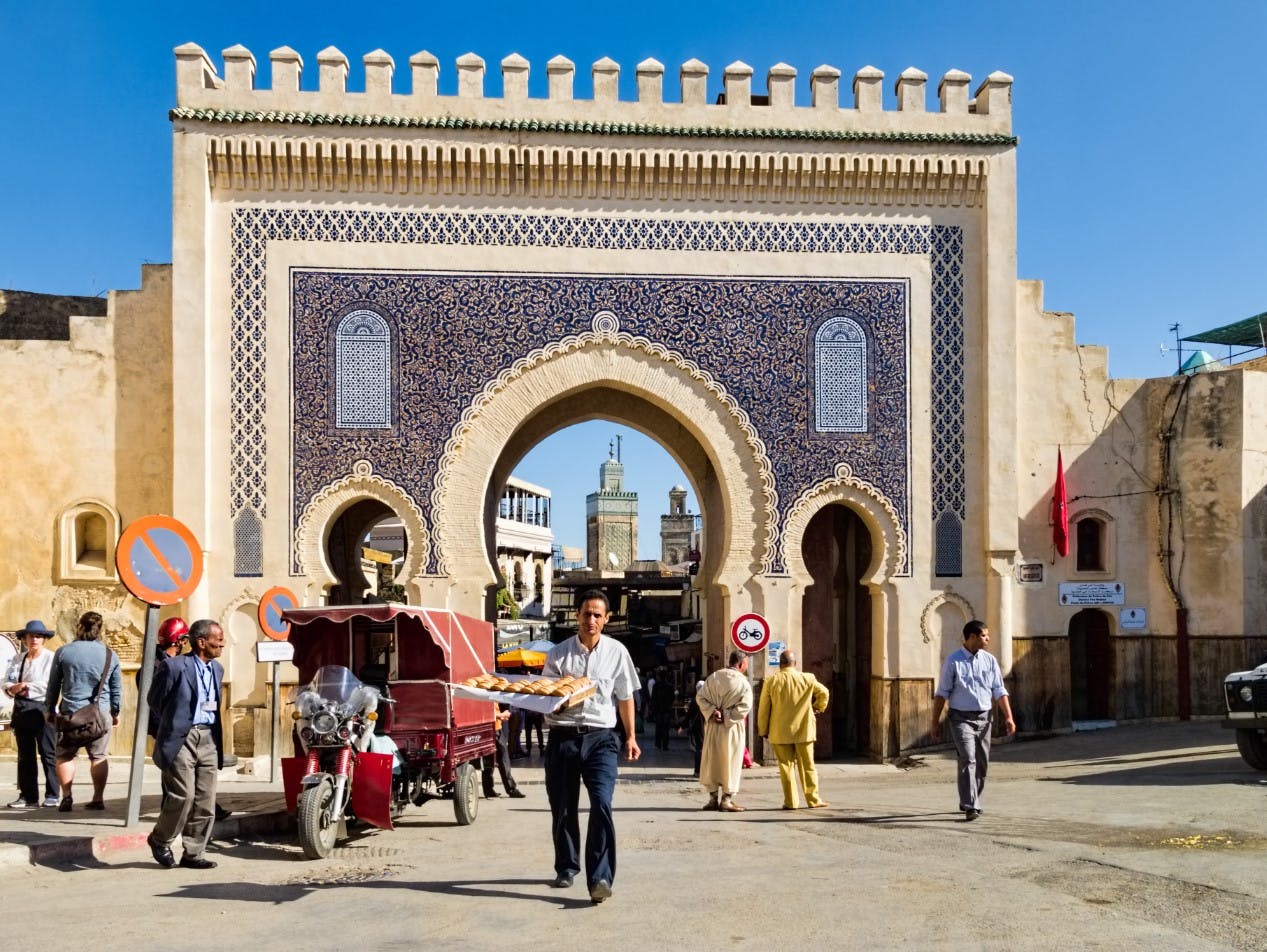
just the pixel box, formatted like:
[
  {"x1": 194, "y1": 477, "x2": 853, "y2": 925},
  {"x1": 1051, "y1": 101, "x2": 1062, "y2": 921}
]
[{"x1": 290, "y1": 267, "x2": 910, "y2": 570}]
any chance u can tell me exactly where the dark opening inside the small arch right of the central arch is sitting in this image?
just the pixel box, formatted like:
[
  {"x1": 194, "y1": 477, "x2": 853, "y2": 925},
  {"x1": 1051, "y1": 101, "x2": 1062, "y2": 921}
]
[{"x1": 801, "y1": 505, "x2": 874, "y2": 757}]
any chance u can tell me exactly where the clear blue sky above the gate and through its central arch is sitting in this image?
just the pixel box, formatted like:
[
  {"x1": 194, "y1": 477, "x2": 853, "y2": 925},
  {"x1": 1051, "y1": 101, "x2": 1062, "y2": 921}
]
[{"x1": 0, "y1": 0, "x2": 1267, "y2": 558}]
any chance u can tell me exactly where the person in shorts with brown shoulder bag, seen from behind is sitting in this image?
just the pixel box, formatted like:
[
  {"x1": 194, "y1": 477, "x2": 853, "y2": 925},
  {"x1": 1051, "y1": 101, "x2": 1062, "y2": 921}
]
[{"x1": 46, "y1": 611, "x2": 123, "y2": 813}]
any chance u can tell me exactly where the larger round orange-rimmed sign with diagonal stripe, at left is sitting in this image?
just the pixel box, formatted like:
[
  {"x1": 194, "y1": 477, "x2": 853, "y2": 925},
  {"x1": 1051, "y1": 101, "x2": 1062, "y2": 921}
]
[{"x1": 115, "y1": 516, "x2": 203, "y2": 605}]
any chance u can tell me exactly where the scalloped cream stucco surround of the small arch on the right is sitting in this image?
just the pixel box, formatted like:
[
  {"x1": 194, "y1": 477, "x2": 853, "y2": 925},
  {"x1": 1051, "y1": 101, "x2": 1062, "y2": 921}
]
[{"x1": 783, "y1": 463, "x2": 906, "y2": 584}]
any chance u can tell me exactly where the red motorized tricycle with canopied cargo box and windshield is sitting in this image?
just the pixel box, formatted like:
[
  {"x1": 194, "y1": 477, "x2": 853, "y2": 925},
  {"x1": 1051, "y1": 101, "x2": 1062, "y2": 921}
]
[{"x1": 281, "y1": 605, "x2": 495, "y2": 858}]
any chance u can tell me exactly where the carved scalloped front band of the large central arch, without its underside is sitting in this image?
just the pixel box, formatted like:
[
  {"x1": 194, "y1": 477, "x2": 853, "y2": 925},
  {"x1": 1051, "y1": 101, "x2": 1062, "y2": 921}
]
[{"x1": 431, "y1": 311, "x2": 778, "y2": 576}]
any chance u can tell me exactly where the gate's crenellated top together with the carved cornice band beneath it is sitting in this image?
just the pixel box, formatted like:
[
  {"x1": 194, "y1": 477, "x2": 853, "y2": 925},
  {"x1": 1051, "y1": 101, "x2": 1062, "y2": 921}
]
[{"x1": 172, "y1": 43, "x2": 1016, "y2": 207}]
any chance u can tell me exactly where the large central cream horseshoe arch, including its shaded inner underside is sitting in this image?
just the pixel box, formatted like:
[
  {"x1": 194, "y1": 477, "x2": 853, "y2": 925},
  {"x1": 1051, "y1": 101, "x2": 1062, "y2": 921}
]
[{"x1": 430, "y1": 334, "x2": 774, "y2": 657}]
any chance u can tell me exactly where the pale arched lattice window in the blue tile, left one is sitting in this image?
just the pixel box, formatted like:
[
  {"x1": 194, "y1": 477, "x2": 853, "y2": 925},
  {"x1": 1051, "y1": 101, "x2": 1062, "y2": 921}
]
[{"x1": 334, "y1": 309, "x2": 392, "y2": 430}]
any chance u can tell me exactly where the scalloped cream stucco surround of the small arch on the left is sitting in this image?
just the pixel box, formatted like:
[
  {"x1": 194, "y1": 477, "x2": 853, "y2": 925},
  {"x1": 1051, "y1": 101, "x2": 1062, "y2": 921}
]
[{"x1": 295, "y1": 459, "x2": 431, "y2": 584}]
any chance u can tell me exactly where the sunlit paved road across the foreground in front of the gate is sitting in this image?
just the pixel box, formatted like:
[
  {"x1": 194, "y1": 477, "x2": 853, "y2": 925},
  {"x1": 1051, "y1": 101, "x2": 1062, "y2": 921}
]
[{"x1": 0, "y1": 723, "x2": 1267, "y2": 952}]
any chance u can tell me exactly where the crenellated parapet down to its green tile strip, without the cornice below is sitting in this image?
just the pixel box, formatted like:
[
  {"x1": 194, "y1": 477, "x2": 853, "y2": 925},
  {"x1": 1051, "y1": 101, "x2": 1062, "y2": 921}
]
[{"x1": 175, "y1": 43, "x2": 1012, "y2": 138}]
